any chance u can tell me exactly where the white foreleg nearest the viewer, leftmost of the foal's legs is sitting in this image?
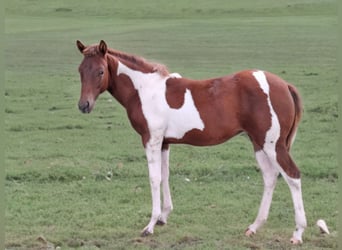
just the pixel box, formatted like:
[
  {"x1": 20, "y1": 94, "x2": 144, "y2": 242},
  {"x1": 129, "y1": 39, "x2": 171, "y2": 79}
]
[{"x1": 141, "y1": 138, "x2": 162, "y2": 236}]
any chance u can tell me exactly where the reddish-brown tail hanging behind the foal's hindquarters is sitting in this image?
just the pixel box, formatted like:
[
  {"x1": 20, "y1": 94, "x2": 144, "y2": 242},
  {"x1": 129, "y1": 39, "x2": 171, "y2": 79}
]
[{"x1": 286, "y1": 84, "x2": 303, "y2": 151}]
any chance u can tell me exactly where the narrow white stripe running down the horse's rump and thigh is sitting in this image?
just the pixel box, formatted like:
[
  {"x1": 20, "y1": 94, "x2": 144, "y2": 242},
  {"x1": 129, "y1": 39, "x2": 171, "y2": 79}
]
[{"x1": 253, "y1": 71, "x2": 280, "y2": 152}]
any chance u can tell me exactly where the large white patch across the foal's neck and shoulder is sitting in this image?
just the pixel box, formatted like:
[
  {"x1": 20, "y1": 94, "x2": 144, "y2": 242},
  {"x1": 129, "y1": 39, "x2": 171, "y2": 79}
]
[{"x1": 117, "y1": 62, "x2": 204, "y2": 139}]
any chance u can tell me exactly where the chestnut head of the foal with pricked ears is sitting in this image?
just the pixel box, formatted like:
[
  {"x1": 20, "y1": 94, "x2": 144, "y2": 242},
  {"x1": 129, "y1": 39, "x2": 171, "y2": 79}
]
[{"x1": 76, "y1": 40, "x2": 109, "y2": 113}]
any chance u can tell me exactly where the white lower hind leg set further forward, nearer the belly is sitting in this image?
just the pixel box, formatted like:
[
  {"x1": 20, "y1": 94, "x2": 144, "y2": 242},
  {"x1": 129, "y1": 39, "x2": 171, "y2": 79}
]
[{"x1": 245, "y1": 150, "x2": 279, "y2": 236}]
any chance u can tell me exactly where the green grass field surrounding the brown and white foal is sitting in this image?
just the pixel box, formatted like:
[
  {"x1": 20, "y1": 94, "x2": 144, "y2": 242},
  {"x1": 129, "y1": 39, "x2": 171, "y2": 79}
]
[{"x1": 4, "y1": 0, "x2": 338, "y2": 250}]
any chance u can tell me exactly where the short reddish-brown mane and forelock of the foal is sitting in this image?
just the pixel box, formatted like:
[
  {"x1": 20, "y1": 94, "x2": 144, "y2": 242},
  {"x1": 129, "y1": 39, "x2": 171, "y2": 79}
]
[{"x1": 83, "y1": 45, "x2": 169, "y2": 76}]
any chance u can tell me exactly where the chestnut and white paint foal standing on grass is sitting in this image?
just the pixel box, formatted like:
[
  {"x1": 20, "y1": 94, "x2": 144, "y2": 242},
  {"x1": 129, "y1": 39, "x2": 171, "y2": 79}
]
[{"x1": 76, "y1": 41, "x2": 306, "y2": 244}]
